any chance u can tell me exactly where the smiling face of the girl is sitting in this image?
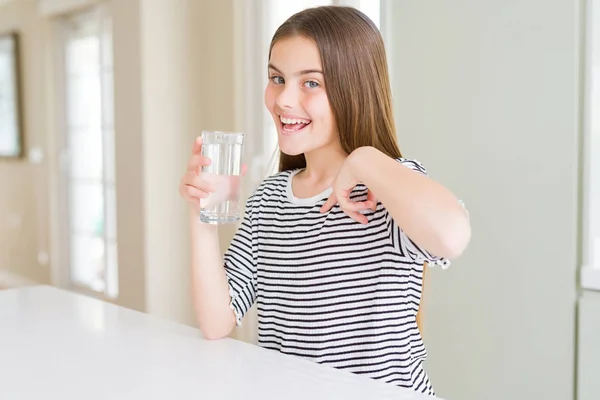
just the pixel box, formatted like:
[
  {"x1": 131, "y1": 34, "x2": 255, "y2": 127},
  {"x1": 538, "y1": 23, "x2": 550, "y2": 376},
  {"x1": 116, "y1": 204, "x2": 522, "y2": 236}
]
[{"x1": 265, "y1": 36, "x2": 341, "y2": 156}]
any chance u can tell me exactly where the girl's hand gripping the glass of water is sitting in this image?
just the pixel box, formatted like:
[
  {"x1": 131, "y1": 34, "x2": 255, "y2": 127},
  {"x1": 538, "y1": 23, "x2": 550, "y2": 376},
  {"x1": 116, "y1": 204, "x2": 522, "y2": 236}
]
[{"x1": 179, "y1": 137, "x2": 216, "y2": 212}]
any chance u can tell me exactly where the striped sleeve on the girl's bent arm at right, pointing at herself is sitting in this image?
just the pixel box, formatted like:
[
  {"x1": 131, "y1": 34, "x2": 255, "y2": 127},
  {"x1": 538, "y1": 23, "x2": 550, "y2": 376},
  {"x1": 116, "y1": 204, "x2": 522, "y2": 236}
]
[{"x1": 388, "y1": 158, "x2": 468, "y2": 269}]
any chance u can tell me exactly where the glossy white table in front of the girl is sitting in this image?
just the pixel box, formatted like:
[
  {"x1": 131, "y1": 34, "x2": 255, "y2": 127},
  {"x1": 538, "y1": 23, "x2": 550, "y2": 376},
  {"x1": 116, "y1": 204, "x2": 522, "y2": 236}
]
[{"x1": 0, "y1": 286, "x2": 446, "y2": 400}]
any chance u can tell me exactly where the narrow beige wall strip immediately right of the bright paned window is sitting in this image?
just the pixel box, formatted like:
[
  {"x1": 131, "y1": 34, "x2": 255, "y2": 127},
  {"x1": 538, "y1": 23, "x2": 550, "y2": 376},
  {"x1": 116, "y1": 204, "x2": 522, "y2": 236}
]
[{"x1": 108, "y1": 0, "x2": 147, "y2": 311}]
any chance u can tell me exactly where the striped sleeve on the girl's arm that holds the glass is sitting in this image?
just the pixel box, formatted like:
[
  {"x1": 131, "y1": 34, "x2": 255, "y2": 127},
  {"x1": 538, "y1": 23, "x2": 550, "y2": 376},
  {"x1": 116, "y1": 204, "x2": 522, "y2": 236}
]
[{"x1": 223, "y1": 193, "x2": 257, "y2": 326}]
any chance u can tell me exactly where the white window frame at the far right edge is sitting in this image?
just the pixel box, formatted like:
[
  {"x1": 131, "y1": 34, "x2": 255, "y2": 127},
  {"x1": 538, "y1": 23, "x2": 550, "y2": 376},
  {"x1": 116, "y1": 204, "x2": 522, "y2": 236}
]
[{"x1": 580, "y1": 0, "x2": 600, "y2": 290}]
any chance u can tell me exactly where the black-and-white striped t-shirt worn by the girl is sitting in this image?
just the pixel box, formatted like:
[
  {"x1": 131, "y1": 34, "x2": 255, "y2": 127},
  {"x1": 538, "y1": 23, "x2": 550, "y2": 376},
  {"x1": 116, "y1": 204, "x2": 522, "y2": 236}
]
[{"x1": 224, "y1": 159, "x2": 449, "y2": 394}]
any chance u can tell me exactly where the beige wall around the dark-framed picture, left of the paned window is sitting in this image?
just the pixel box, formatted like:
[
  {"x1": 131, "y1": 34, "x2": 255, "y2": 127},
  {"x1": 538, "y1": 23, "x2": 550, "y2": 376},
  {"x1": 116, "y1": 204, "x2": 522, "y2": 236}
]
[{"x1": 0, "y1": 0, "x2": 50, "y2": 283}]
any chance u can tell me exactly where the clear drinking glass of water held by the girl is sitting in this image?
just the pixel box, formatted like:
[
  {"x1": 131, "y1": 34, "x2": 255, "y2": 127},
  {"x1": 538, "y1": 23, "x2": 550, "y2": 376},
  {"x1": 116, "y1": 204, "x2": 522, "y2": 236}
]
[{"x1": 200, "y1": 131, "x2": 244, "y2": 224}]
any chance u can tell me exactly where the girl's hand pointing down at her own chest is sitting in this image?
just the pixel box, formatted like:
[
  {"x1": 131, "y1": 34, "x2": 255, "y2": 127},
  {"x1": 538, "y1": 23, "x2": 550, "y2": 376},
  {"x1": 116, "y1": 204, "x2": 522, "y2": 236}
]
[{"x1": 320, "y1": 162, "x2": 377, "y2": 224}]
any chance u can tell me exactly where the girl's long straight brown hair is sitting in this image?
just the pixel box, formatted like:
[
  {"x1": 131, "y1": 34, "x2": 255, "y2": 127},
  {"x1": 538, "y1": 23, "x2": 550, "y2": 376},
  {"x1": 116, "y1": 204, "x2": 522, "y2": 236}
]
[{"x1": 269, "y1": 6, "x2": 402, "y2": 171}]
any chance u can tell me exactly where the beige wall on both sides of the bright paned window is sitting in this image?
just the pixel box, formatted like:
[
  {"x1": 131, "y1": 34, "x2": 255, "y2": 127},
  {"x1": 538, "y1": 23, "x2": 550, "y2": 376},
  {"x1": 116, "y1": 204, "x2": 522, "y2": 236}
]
[{"x1": 0, "y1": 0, "x2": 151, "y2": 310}]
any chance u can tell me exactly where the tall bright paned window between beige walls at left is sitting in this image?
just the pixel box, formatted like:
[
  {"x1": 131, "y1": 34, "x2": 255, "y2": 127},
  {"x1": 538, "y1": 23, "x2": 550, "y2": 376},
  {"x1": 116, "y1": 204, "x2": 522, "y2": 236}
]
[{"x1": 61, "y1": 10, "x2": 118, "y2": 298}]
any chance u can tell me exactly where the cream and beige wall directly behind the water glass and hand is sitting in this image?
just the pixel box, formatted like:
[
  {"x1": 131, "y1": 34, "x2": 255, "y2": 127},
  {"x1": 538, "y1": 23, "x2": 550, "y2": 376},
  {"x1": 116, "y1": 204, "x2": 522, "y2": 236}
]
[{"x1": 140, "y1": 0, "x2": 240, "y2": 323}]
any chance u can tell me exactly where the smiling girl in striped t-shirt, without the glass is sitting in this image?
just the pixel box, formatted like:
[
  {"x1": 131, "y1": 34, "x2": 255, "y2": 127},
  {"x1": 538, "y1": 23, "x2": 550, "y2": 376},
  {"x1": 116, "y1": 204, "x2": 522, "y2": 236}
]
[{"x1": 180, "y1": 6, "x2": 470, "y2": 394}]
